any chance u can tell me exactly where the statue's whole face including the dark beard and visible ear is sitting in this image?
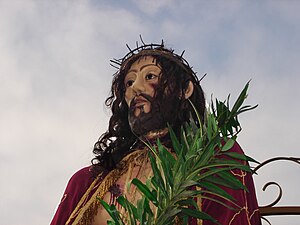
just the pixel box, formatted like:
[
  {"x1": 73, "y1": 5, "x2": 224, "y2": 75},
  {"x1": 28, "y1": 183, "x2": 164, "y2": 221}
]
[{"x1": 124, "y1": 56, "x2": 193, "y2": 136}]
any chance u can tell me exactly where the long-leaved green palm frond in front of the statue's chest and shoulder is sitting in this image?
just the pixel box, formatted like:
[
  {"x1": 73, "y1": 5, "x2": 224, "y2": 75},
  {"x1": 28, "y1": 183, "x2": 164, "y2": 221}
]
[{"x1": 100, "y1": 82, "x2": 257, "y2": 225}]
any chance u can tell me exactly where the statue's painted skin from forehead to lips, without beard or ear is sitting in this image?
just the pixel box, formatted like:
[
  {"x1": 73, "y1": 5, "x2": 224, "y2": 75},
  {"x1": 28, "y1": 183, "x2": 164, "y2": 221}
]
[{"x1": 124, "y1": 56, "x2": 161, "y2": 117}]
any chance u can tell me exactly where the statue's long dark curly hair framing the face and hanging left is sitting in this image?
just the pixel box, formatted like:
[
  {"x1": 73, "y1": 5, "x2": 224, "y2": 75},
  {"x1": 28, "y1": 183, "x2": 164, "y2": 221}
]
[{"x1": 92, "y1": 44, "x2": 205, "y2": 175}]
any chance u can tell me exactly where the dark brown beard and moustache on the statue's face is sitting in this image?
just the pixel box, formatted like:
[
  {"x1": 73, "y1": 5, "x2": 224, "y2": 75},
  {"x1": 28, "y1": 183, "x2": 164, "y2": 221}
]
[{"x1": 128, "y1": 94, "x2": 179, "y2": 136}]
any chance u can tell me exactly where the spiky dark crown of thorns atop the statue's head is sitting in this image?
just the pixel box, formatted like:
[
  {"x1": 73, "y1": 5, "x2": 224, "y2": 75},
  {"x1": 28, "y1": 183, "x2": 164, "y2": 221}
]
[{"x1": 110, "y1": 37, "x2": 206, "y2": 82}]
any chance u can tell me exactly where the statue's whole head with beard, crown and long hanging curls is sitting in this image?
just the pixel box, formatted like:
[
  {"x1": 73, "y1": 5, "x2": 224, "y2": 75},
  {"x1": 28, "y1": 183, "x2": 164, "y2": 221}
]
[{"x1": 93, "y1": 40, "x2": 205, "y2": 171}]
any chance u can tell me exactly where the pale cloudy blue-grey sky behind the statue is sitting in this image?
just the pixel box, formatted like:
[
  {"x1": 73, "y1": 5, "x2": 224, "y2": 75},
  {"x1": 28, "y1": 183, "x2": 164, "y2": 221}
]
[{"x1": 0, "y1": 0, "x2": 300, "y2": 225}]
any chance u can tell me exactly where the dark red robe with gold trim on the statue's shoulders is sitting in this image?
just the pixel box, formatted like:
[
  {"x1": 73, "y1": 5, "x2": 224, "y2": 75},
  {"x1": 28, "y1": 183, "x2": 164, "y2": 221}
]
[{"x1": 50, "y1": 144, "x2": 261, "y2": 225}]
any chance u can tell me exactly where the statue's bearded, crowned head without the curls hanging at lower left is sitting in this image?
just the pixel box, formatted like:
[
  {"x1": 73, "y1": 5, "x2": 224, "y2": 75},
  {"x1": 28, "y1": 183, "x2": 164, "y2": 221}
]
[{"x1": 111, "y1": 44, "x2": 205, "y2": 136}]
